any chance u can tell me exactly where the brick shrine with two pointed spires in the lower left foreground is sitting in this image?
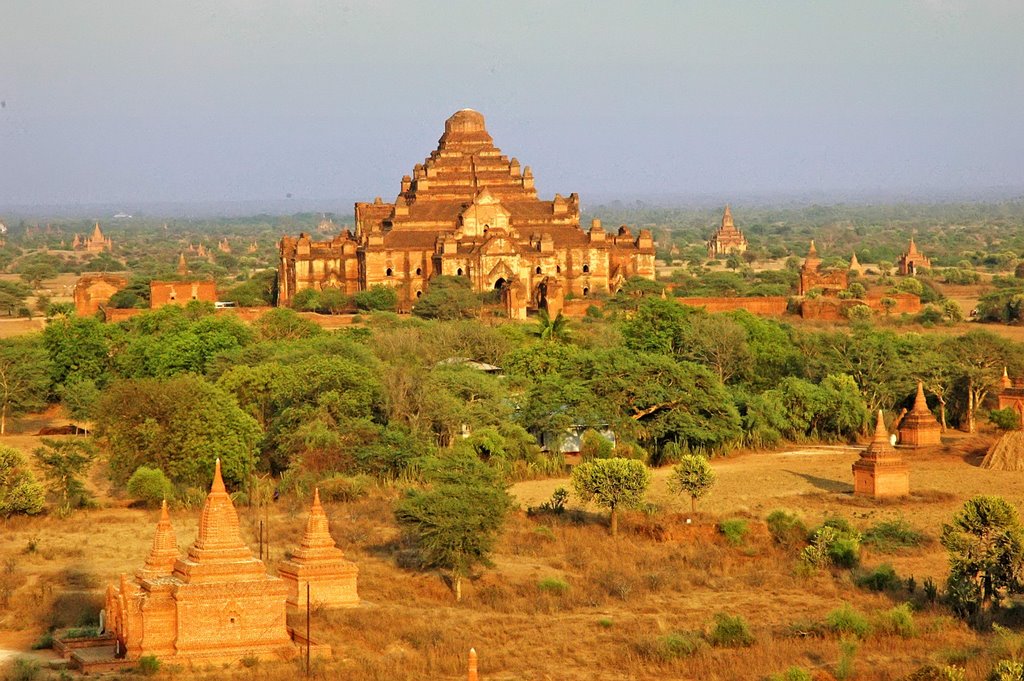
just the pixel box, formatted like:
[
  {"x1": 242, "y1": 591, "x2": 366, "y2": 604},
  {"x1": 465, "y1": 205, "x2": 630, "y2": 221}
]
[{"x1": 106, "y1": 460, "x2": 298, "y2": 664}]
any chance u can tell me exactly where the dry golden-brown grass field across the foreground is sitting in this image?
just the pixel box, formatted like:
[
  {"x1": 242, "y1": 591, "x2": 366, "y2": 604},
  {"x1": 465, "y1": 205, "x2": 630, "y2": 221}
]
[{"x1": 0, "y1": 426, "x2": 1024, "y2": 681}]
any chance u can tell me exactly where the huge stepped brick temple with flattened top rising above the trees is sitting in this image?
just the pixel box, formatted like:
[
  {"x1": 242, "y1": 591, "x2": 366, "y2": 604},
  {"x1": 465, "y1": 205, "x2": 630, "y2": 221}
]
[{"x1": 278, "y1": 109, "x2": 654, "y2": 318}]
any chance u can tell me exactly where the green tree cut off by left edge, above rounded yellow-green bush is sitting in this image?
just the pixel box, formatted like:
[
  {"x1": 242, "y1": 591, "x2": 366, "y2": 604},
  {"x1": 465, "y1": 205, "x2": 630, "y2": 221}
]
[{"x1": 0, "y1": 337, "x2": 52, "y2": 435}]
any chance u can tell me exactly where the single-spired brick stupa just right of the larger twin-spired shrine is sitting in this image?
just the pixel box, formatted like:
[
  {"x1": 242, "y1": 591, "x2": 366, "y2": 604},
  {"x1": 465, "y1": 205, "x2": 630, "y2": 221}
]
[{"x1": 278, "y1": 490, "x2": 359, "y2": 607}]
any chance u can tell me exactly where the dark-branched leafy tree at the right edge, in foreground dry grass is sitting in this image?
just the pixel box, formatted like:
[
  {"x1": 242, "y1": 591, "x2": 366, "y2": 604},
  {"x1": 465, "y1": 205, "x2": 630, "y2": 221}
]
[{"x1": 940, "y1": 497, "x2": 1024, "y2": 628}]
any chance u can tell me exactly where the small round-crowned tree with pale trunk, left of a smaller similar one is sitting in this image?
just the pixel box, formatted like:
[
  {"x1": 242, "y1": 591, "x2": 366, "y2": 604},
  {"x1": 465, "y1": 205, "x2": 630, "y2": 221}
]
[{"x1": 572, "y1": 458, "x2": 650, "y2": 537}]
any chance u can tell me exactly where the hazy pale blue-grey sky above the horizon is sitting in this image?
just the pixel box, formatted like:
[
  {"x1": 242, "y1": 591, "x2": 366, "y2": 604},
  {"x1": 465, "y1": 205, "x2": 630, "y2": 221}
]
[{"x1": 0, "y1": 0, "x2": 1024, "y2": 208}]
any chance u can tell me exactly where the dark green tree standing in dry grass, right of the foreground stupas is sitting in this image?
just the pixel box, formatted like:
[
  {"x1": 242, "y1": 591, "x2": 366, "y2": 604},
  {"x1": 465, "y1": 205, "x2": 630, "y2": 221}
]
[{"x1": 395, "y1": 456, "x2": 511, "y2": 601}]
